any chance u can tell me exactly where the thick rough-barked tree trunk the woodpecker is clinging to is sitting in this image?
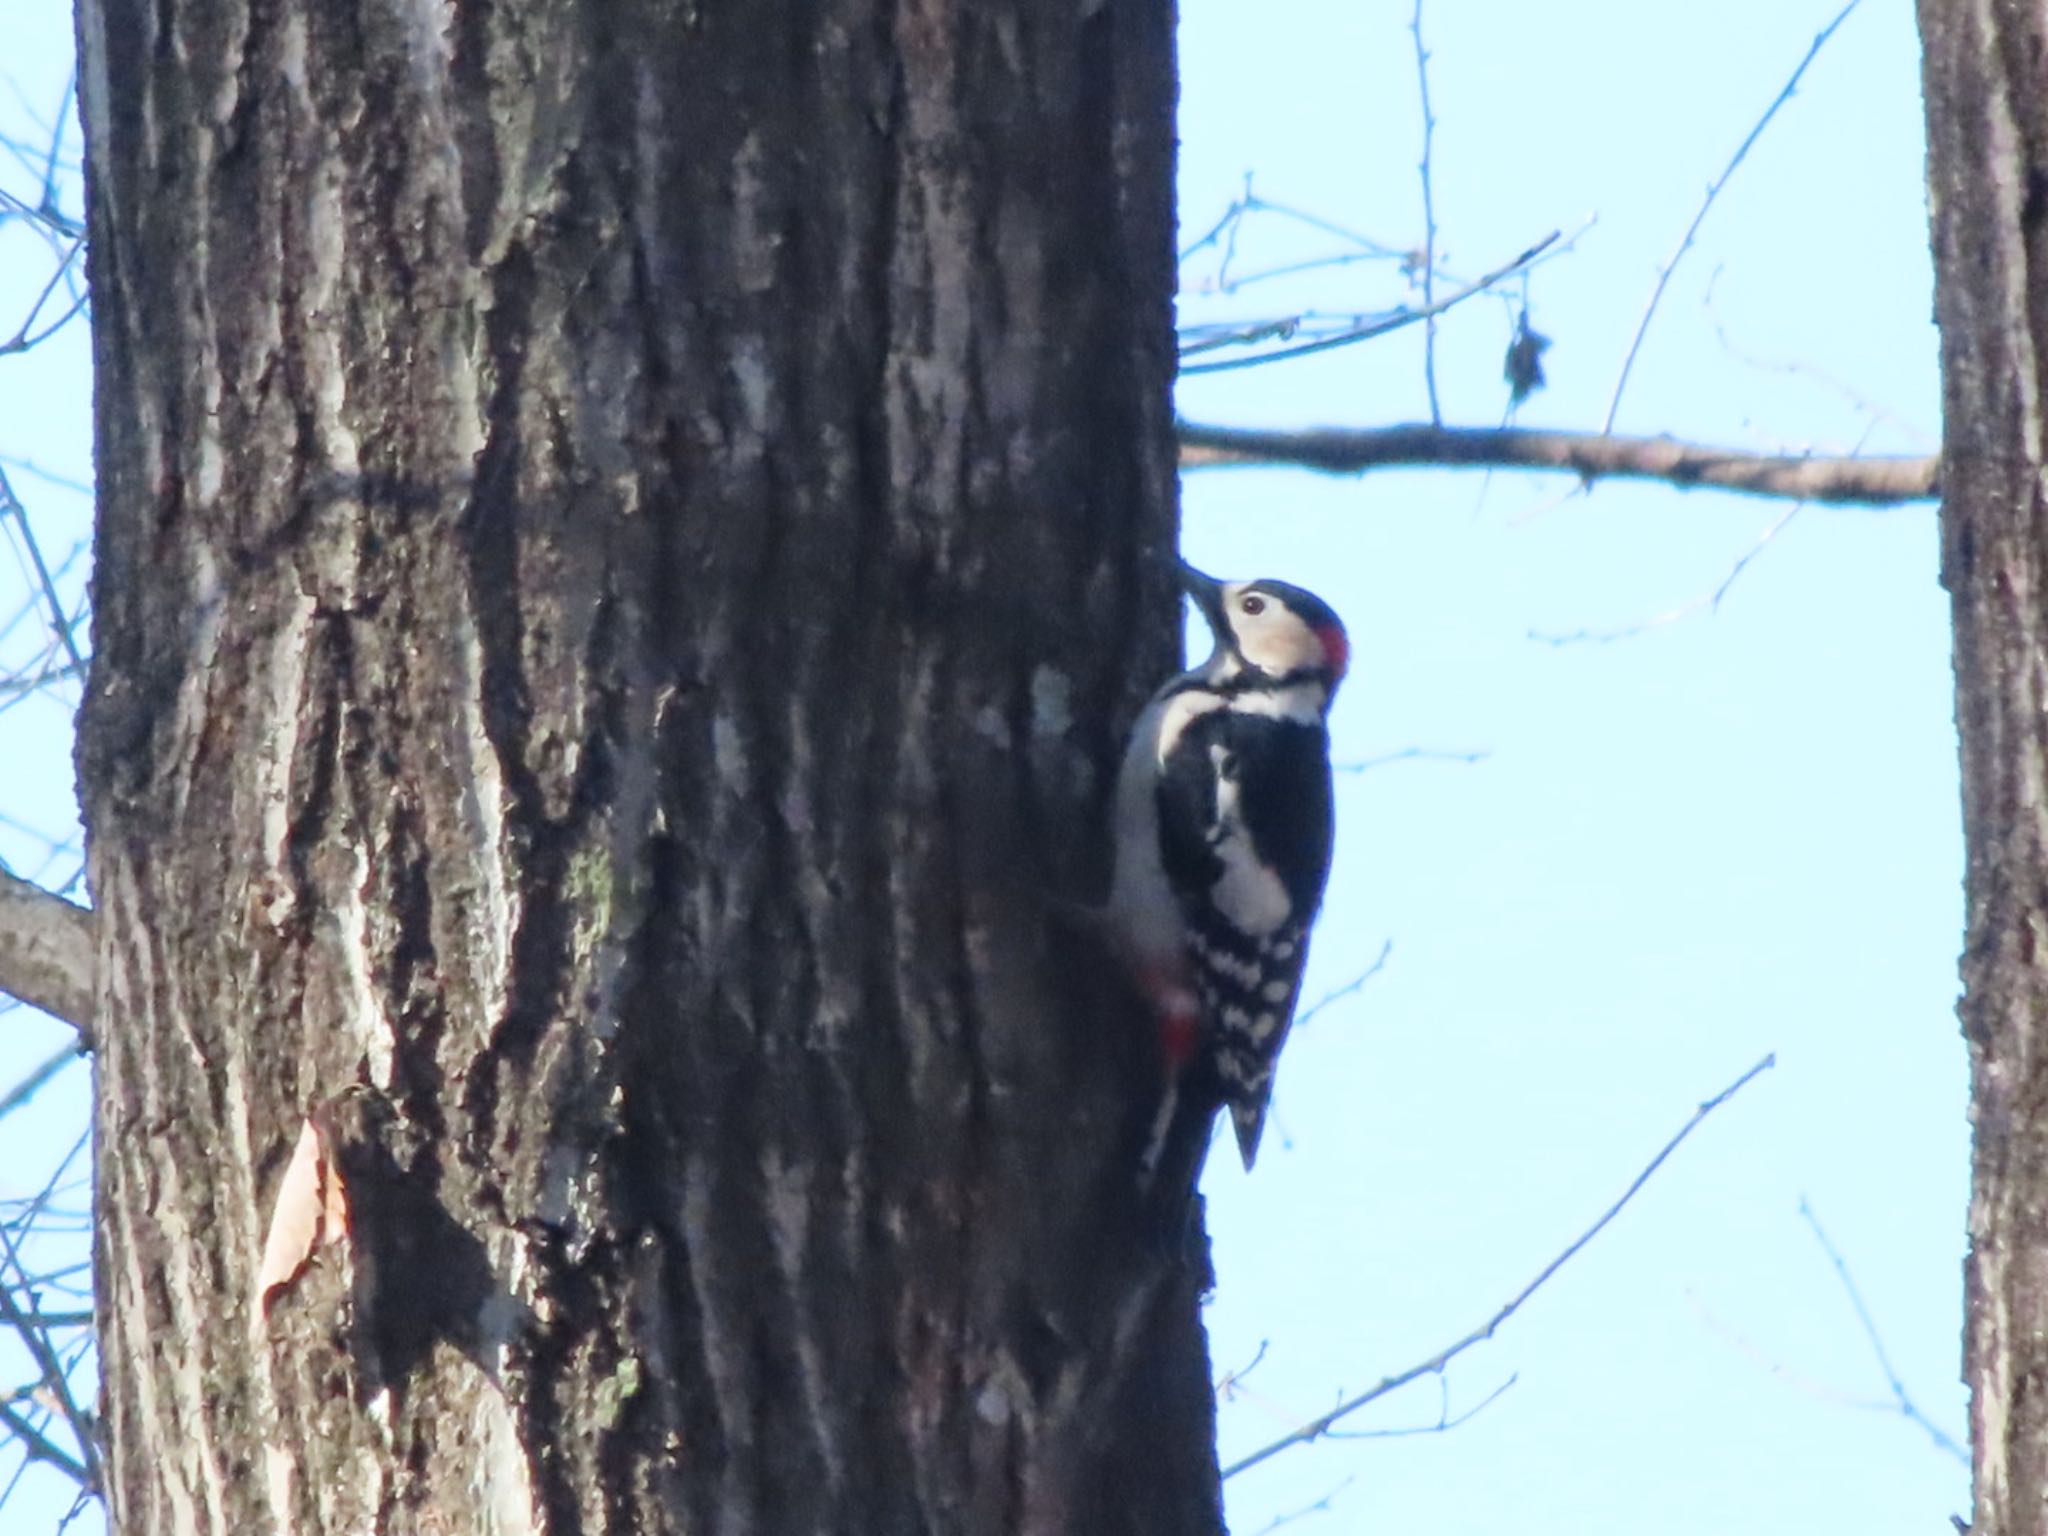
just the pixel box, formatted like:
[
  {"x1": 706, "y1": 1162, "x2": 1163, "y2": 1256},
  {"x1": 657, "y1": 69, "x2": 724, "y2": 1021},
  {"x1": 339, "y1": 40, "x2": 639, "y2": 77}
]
[{"x1": 80, "y1": 0, "x2": 1221, "y2": 1536}]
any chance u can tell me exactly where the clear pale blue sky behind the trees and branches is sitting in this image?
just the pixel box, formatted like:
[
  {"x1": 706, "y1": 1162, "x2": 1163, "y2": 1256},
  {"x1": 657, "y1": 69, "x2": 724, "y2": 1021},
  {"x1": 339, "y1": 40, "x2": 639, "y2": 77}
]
[{"x1": 0, "y1": 0, "x2": 1968, "y2": 1536}]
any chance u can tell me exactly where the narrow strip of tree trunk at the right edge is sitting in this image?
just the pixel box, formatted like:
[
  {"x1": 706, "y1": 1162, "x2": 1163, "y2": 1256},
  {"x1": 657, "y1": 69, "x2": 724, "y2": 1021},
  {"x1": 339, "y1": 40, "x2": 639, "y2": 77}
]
[{"x1": 1919, "y1": 0, "x2": 2048, "y2": 1536}]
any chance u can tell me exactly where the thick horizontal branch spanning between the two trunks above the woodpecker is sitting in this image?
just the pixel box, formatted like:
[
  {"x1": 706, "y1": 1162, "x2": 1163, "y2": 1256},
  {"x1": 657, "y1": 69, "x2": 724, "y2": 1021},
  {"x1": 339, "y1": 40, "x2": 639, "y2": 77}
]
[{"x1": 1180, "y1": 422, "x2": 1942, "y2": 506}]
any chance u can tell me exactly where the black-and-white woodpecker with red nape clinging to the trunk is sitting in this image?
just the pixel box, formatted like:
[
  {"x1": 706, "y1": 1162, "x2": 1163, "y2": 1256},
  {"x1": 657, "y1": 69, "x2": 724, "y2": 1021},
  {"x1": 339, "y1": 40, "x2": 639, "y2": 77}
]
[{"x1": 1110, "y1": 565, "x2": 1350, "y2": 1188}]
